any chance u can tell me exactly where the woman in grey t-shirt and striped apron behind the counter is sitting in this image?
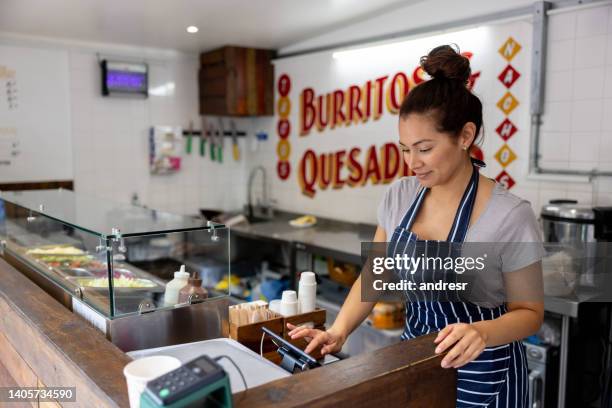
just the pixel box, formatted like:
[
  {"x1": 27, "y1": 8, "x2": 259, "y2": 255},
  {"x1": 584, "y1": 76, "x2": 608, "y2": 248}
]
[{"x1": 289, "y1": 45, "x2": 544, "y2": 408}]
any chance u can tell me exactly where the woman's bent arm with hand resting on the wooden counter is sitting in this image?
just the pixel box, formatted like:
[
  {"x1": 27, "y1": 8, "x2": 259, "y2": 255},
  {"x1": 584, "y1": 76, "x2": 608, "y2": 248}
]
[{"x1": 434, "y1": 261, "x2": 544, "y2": 368}]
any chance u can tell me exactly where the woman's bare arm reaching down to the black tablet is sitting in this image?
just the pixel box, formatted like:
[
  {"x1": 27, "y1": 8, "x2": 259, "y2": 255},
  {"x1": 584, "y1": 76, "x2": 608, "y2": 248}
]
[{"x1": 288, "y1": 227, "x2": 387, "y2": 354}]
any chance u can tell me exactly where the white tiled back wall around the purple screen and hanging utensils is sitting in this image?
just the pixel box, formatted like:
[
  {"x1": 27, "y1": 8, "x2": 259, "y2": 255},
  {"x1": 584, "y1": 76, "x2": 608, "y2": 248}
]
[{"x1": 70, "y1": 51, "x2": 249, "y2": 214}]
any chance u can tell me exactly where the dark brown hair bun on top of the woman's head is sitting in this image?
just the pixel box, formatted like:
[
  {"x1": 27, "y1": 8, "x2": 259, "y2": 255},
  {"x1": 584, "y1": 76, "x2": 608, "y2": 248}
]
[{"x1": 421, "y1": 45, "x2": 471, "y2": 84}]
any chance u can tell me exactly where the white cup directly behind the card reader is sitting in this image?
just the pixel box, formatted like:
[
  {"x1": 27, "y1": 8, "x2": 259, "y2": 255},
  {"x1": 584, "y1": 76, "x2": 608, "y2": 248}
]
[{"x1": 123, "y1": 356, "x2": 181, "y2": 408}]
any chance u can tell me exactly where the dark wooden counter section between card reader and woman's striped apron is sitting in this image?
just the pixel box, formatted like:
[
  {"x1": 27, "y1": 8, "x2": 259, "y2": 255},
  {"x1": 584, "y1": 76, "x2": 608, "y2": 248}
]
[{"x1": 234, "y1": 334, "x2": 457, "y2": 408}]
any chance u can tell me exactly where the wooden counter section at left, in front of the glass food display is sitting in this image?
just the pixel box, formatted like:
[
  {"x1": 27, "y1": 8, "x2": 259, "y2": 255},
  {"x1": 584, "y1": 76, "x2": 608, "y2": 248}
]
[{"x1": 0, "y1": 258, "x2": 130, "y2": 407}]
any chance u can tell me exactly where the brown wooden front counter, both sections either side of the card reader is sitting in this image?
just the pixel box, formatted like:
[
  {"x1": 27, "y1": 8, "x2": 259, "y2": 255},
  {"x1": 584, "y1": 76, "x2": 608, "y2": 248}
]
[{"x1": 0, "y1": 258, "x2": 456, "y2": 408}]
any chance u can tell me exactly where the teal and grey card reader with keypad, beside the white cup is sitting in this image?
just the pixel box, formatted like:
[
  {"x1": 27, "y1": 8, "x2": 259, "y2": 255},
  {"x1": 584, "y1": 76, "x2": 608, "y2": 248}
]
[{"x1": 140, "y1": 355, "x2": 232, "y2": 408}]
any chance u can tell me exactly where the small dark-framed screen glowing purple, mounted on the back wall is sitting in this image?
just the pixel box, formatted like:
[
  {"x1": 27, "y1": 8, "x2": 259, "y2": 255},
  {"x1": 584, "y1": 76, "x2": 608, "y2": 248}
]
[{"x1": 101, "y1": 60, "x2": 149, "y2": 96}]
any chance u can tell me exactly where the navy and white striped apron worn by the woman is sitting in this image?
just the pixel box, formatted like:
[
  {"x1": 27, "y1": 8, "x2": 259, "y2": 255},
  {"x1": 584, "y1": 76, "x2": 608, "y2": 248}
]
[{"x1": 388, "y1": 160, "x2": 528, "y2": 408}]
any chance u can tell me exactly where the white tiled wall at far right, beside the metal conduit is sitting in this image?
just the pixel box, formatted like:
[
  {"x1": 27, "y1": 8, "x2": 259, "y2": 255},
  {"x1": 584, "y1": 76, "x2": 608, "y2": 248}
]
[{"x1": 516, "y1": 5, "x2": 612, "y2": 214}]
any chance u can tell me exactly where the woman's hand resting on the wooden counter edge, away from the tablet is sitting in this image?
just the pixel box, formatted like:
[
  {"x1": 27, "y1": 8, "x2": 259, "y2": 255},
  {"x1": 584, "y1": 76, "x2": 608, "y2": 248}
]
[{"x1": 434, "y1": 323, "x2": 487, "y2": 368}]
